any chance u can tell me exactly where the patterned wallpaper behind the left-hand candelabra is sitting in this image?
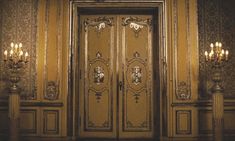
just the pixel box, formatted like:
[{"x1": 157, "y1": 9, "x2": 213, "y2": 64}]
[{"x1": 0, "y1": 0, "x2": 38, "y2": 99}]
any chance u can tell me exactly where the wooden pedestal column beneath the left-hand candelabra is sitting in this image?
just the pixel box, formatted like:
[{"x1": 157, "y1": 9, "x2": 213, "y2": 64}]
[{"x1": 8, "y1": 93, "x2": 20, "y2": 141}]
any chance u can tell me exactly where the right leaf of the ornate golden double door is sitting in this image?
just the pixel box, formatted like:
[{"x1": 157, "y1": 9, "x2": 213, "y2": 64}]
[{"x1": 119, "y1": 15, "x2": 153, "y2": 137}]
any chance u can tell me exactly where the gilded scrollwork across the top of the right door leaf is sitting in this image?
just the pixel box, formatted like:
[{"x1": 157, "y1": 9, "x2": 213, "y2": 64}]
[{"x1": 122, "y1": 17, "x2": 152, "y2": 37}]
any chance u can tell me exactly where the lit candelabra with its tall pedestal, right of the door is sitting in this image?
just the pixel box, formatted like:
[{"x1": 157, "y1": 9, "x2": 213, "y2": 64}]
[{"x1": 205, "y1": 42, "x2": 229, "y2": 141}]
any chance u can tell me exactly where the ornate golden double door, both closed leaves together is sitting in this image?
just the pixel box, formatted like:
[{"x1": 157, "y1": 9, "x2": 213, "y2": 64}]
[{"x1": 79, "y1": 15, "x2": 154, "y2": 138}]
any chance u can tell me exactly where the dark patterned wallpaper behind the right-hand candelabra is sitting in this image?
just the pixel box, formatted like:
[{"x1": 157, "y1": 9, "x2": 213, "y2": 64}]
[{"x1": 198, "y1": 0, "x2": 235, "y2": 99}]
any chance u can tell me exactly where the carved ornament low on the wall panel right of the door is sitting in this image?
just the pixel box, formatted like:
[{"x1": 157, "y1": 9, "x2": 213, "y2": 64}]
[{"x1": 176, "y1": 81, "x2": 191, "y2": 100}]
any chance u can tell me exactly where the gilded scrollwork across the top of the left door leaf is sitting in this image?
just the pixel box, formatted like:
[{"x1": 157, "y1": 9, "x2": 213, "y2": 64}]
[{"x1": 84, "y1": 17, "x2": 113, "y2": 33}]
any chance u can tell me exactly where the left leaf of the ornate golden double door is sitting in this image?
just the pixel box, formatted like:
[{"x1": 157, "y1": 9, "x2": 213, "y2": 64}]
[{"x1": 80, "y1": 15, "x2": 116, "y2": 137}]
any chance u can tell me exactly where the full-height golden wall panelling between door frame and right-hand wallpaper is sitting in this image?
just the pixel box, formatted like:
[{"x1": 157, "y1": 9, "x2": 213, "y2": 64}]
[{"x1": 167, "y1": 0, "x2": 198, "y2": 137}]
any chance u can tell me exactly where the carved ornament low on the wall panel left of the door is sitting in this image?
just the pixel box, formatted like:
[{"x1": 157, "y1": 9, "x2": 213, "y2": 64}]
[{"x1": 44, "y1": 81, "x2": 58, "y2": 100}]
